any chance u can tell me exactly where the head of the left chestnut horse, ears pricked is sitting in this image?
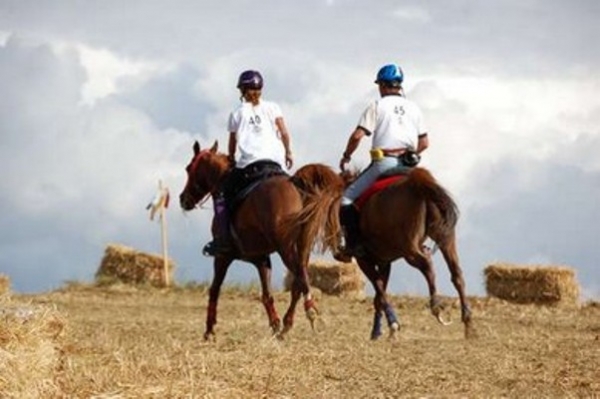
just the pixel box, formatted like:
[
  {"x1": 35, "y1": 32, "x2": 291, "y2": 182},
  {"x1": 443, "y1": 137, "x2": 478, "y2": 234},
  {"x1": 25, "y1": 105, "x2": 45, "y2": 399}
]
[{"x1": 179, "y1": 140, "x2": 231, "y2": 211}]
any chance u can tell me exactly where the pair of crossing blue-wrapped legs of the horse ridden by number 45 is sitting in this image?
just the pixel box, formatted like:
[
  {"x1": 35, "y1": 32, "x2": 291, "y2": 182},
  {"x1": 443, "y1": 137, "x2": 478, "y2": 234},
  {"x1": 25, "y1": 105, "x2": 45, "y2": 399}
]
[{"x1": 357, "y1": 258, "x2": 400, "y2": 340}]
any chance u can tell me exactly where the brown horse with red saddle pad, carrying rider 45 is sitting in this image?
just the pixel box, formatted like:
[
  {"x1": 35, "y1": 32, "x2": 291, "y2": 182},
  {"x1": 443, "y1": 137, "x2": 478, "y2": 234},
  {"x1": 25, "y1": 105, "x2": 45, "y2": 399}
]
[{"x1": 298, "y1": 168, "x2": 473, "y2": 339}]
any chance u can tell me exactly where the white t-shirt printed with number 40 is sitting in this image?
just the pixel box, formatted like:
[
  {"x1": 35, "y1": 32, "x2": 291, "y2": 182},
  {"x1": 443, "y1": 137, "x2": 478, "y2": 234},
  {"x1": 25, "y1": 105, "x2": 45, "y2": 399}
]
[{"x1": 227, "y1": 100, "x2": 285, "y2": 168}]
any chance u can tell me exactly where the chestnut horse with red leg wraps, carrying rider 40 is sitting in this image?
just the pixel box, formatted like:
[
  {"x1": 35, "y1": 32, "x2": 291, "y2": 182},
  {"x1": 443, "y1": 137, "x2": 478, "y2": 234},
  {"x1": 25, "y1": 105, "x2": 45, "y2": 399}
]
[{"x1": 179, "y1": 141, "x2": 338, "y2": 339}]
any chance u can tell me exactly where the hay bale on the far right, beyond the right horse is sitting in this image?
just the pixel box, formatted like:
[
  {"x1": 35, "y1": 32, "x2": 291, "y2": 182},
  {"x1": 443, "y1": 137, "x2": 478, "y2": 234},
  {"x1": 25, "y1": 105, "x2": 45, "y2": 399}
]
[{"x1": 484, "y1": 263, "x2": 579, "y2": 305}]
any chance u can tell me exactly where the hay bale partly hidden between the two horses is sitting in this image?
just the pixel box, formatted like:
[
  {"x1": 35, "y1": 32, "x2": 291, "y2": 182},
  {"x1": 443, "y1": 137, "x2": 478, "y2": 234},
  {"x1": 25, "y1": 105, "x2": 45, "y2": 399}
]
[{"x1": 283, "y1": 260, "x2": 365, "y2": 297}]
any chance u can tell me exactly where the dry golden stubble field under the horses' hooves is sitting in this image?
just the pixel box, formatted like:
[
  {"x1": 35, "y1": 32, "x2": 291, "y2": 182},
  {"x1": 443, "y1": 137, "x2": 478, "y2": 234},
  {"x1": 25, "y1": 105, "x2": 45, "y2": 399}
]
[{"x1": 0, "y1": 284, "x2": 600, "y2": 398}]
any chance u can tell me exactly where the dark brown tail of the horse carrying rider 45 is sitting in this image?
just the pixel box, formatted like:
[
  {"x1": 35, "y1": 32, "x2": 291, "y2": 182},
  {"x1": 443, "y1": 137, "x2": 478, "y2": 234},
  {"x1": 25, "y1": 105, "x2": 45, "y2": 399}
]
[{"x1": 406, "y1": 168, "x2": 459, "y2": 245}]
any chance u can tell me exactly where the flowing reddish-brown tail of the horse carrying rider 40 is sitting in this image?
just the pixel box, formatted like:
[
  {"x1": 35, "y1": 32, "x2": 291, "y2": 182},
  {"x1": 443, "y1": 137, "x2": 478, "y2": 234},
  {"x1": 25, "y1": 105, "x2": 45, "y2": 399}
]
[{"x1": 284, "y1": 164, "x2": 344, "y2": 258}]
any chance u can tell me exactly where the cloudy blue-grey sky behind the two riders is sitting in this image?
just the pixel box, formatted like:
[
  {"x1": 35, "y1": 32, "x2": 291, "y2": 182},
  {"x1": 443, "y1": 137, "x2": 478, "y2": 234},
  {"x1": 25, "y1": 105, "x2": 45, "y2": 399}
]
[{"x1": 0, "y1": 0, "x2": 600, "y2": 298}]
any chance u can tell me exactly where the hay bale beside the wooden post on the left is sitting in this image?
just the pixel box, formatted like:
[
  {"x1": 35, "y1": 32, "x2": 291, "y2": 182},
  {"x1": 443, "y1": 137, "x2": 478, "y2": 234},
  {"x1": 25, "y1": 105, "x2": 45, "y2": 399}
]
[{"x1": 96, "y1": 244, "x2": 175, "y2": 287}]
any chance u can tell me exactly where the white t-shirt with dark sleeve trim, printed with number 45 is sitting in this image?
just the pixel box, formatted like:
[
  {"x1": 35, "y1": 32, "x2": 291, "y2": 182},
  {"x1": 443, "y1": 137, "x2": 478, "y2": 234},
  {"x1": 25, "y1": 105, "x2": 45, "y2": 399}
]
[{"x1": 358, "y1": 95, "x2": 427, "y2": 150}]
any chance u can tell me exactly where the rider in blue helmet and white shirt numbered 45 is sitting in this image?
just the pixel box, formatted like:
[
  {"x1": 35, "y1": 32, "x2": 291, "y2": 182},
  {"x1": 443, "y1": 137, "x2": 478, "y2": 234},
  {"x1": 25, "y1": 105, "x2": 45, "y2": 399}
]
[{"x1": 334, "y1": 64, "x2": 429, "y2": 262}]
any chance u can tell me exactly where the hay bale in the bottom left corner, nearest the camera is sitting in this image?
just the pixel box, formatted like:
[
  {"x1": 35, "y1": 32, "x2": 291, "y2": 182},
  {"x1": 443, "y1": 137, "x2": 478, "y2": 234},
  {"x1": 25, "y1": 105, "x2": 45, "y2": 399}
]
[{"x1": 0, "y1": 296, "x2": 65, "y2": 398}]
